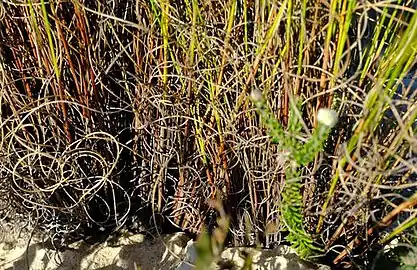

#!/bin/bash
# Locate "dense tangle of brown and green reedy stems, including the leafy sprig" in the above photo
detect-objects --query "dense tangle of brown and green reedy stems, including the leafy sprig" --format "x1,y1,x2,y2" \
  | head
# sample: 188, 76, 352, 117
0, 0, 417, 267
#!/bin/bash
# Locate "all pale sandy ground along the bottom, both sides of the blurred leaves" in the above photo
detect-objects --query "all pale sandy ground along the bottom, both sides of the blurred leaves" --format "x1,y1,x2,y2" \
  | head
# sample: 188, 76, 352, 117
0, 219, 330, 270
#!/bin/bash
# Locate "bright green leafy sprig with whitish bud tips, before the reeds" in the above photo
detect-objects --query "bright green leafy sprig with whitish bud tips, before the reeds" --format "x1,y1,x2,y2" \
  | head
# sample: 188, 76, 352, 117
251, 90, 337, 258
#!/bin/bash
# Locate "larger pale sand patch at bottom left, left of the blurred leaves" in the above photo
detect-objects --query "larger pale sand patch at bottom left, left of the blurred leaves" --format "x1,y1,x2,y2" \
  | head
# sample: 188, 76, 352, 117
0, 219, 189, 270
